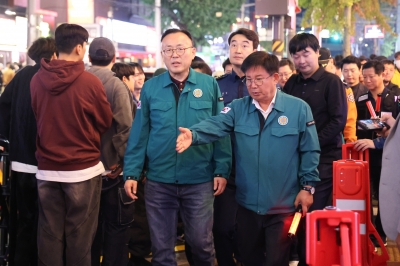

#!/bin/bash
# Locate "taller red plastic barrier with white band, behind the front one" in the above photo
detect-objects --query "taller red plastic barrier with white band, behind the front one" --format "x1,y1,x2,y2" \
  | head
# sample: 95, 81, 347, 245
333, 144, 389, 266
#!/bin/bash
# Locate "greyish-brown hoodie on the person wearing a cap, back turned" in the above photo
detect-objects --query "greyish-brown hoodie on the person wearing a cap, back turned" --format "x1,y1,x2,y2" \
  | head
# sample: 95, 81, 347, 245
88, 66, 134, 170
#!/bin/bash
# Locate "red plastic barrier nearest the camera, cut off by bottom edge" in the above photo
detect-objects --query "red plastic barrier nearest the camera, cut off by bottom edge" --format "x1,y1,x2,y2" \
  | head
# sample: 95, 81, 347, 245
306, 207, 363, 266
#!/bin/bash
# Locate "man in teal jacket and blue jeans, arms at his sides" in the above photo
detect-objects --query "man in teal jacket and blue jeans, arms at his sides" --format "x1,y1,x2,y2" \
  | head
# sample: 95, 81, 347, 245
124, 29, 232, 266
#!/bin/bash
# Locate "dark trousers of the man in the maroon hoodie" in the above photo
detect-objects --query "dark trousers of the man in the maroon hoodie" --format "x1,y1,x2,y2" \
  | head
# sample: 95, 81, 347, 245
37, 176, 101, 266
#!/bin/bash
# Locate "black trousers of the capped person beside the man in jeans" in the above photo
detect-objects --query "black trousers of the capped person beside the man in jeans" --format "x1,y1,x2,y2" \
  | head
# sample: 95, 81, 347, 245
91, 176, 134, 266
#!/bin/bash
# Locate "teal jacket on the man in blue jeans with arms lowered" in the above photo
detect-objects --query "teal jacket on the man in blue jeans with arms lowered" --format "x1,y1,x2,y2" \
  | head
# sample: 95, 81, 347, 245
124, 69, 232, 184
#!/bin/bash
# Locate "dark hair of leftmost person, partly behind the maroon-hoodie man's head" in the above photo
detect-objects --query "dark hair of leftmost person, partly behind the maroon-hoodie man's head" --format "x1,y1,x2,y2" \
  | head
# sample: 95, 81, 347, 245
28, 37, 57, 64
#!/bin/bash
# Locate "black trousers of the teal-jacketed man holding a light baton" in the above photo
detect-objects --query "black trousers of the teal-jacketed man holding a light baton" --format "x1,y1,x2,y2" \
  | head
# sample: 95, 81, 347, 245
237, 205, 294, 266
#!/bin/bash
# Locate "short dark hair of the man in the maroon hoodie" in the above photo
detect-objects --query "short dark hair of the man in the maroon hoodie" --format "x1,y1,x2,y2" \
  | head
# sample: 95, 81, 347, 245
55, 23, 89, 54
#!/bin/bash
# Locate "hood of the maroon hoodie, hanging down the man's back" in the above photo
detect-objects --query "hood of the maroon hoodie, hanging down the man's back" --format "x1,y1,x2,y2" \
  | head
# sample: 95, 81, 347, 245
36, 59, 85, 95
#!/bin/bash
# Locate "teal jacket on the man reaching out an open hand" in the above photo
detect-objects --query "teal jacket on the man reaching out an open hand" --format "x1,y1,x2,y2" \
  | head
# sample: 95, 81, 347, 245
190, 91, 320, 215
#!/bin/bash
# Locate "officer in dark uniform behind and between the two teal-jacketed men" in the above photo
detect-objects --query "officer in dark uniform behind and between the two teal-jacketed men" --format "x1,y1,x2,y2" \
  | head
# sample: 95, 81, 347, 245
213, 28, 259, 266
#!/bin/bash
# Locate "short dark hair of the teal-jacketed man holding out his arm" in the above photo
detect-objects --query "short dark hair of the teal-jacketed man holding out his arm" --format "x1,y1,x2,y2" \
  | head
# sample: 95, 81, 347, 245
240, 51, 279, 75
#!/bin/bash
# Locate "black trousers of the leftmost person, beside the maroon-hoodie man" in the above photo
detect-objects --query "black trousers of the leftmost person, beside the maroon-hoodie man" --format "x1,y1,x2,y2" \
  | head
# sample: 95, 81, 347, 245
10, 171, 39, 266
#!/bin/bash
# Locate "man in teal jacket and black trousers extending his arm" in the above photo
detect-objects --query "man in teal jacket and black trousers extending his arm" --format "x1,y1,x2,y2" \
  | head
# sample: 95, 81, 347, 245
176, 52, 320, 266
